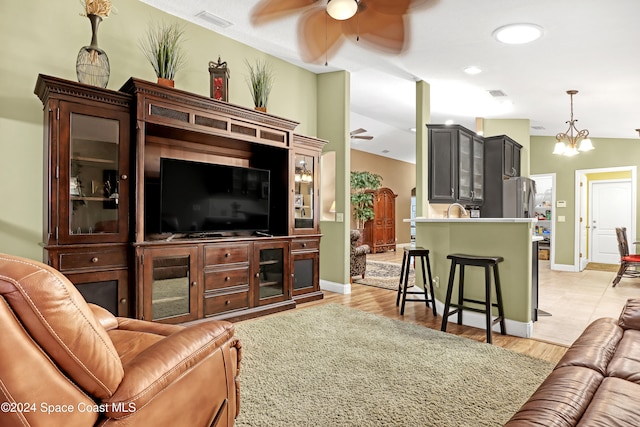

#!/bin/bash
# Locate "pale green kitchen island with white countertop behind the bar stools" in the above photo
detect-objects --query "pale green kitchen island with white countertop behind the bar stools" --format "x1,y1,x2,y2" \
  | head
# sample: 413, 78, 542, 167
405, 218, 537, 338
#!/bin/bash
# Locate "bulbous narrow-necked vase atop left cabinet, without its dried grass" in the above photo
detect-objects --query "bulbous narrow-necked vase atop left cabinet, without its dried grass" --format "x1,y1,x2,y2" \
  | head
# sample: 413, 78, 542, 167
76, 15, 110, 87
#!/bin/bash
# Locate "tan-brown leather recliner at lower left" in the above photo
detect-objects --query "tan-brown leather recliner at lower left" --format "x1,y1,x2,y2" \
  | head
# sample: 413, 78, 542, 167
0, 254, 241, 427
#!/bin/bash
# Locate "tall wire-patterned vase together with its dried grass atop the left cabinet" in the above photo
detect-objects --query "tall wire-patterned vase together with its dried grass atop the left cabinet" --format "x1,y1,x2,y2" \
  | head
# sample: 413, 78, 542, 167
76, 0, 111, 87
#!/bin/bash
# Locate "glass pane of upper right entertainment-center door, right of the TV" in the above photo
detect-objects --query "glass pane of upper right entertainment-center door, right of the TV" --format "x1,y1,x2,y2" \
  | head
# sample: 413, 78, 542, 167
293, 154, 316, 229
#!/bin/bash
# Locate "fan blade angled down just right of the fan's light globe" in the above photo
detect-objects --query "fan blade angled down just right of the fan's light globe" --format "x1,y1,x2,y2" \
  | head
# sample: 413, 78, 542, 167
345, 7, 409, 54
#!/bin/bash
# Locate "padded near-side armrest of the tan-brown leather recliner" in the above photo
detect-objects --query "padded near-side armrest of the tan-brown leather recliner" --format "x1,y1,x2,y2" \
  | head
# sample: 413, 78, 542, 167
104, 321, 238, 419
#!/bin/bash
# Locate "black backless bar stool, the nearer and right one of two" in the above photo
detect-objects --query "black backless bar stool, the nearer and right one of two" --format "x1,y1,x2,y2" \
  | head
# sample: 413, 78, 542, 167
441, 254, 506, 344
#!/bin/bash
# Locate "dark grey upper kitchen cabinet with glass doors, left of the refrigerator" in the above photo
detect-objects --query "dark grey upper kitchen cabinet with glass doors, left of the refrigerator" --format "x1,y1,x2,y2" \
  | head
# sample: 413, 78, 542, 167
427, 125, 485, 205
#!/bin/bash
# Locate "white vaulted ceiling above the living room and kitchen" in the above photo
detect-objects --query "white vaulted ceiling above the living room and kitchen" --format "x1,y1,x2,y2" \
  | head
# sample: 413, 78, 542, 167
142, 0, 640, 162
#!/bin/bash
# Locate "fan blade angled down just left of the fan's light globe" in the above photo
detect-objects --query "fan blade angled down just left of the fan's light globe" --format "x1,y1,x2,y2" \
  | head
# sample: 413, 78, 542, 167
298, 7, 345, 63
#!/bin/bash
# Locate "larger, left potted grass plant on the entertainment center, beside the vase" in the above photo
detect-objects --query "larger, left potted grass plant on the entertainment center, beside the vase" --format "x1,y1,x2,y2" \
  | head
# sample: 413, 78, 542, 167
140, 22, 185, 87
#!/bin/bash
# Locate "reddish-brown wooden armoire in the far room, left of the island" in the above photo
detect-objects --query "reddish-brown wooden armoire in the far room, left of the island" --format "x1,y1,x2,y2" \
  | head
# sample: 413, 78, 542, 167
363, 187, 398, 254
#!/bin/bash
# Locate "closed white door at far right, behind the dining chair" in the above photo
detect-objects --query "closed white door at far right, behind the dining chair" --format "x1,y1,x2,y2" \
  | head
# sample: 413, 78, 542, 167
589, 180, 632, 264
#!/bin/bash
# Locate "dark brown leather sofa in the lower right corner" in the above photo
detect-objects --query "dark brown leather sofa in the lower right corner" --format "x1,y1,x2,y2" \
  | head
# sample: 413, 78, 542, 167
506, 299, 640, 427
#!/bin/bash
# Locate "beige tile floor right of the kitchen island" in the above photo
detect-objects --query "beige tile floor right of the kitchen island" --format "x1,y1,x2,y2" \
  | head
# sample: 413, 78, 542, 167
533, 261, 640, 345
